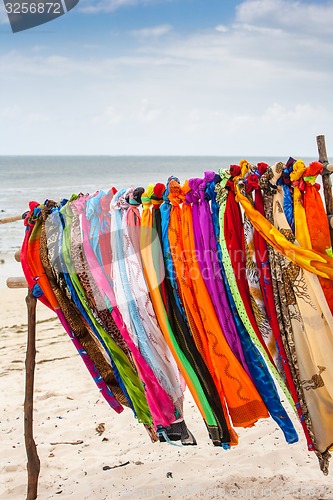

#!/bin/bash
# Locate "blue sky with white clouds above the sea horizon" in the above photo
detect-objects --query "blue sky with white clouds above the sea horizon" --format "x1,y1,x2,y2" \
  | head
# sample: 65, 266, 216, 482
0, 0, 333, 157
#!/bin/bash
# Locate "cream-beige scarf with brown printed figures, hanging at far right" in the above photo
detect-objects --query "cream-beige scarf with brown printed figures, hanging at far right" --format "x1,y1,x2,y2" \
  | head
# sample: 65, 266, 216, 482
274, 172, 333, 474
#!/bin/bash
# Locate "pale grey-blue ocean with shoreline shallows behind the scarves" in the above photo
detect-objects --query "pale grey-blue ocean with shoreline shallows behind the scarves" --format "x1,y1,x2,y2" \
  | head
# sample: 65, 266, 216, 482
0, 156, 317, 287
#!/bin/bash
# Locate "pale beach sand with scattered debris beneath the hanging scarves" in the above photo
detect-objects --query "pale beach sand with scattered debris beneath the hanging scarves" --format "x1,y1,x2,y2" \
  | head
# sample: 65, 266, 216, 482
0, 288, 333, 500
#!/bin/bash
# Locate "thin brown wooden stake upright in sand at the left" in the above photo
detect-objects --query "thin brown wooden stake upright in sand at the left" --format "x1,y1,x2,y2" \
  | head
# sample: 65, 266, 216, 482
24, 290, 40, 500
